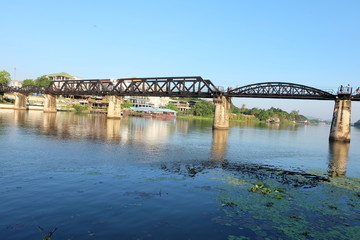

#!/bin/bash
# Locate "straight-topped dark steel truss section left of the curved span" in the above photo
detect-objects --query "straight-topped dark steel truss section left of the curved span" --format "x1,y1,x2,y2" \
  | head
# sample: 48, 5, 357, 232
47, 77, 220, 98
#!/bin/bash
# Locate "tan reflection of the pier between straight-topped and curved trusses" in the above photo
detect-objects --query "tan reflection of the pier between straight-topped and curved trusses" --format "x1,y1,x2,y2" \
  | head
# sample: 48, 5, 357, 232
211, 129, 229, 162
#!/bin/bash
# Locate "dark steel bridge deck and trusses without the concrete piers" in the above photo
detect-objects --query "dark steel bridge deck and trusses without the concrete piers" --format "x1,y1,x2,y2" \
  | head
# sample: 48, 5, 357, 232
0, 77, 360, 101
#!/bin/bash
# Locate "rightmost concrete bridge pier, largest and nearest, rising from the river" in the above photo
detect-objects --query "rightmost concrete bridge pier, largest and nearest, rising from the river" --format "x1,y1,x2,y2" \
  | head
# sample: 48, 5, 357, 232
329, 99, 351, 142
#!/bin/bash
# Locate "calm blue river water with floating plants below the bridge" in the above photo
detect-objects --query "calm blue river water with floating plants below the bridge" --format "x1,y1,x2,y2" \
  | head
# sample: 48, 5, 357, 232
0, 110, 360, 240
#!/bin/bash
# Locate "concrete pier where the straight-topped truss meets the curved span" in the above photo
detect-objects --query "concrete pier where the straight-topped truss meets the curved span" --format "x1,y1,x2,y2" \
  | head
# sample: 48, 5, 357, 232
213, 96, 231, 129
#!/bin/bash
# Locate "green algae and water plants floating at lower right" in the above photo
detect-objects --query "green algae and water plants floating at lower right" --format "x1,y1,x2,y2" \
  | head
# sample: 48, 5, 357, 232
212, 173, 360, 240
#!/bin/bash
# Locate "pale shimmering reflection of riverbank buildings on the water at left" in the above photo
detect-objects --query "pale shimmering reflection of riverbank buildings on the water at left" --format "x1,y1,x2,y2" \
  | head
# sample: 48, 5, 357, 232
0, 110, 179, 145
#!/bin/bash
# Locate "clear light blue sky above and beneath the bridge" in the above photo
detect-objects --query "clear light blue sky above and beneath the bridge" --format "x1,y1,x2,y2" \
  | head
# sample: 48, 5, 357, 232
0, 0, 360, 121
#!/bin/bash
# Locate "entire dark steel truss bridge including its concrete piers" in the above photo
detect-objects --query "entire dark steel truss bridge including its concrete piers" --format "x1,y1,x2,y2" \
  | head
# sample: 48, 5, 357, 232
0, 77, 360, 142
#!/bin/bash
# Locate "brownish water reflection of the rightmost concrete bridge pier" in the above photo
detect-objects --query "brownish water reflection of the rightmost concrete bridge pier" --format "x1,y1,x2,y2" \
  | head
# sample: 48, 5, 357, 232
328, 142, 350, 177
